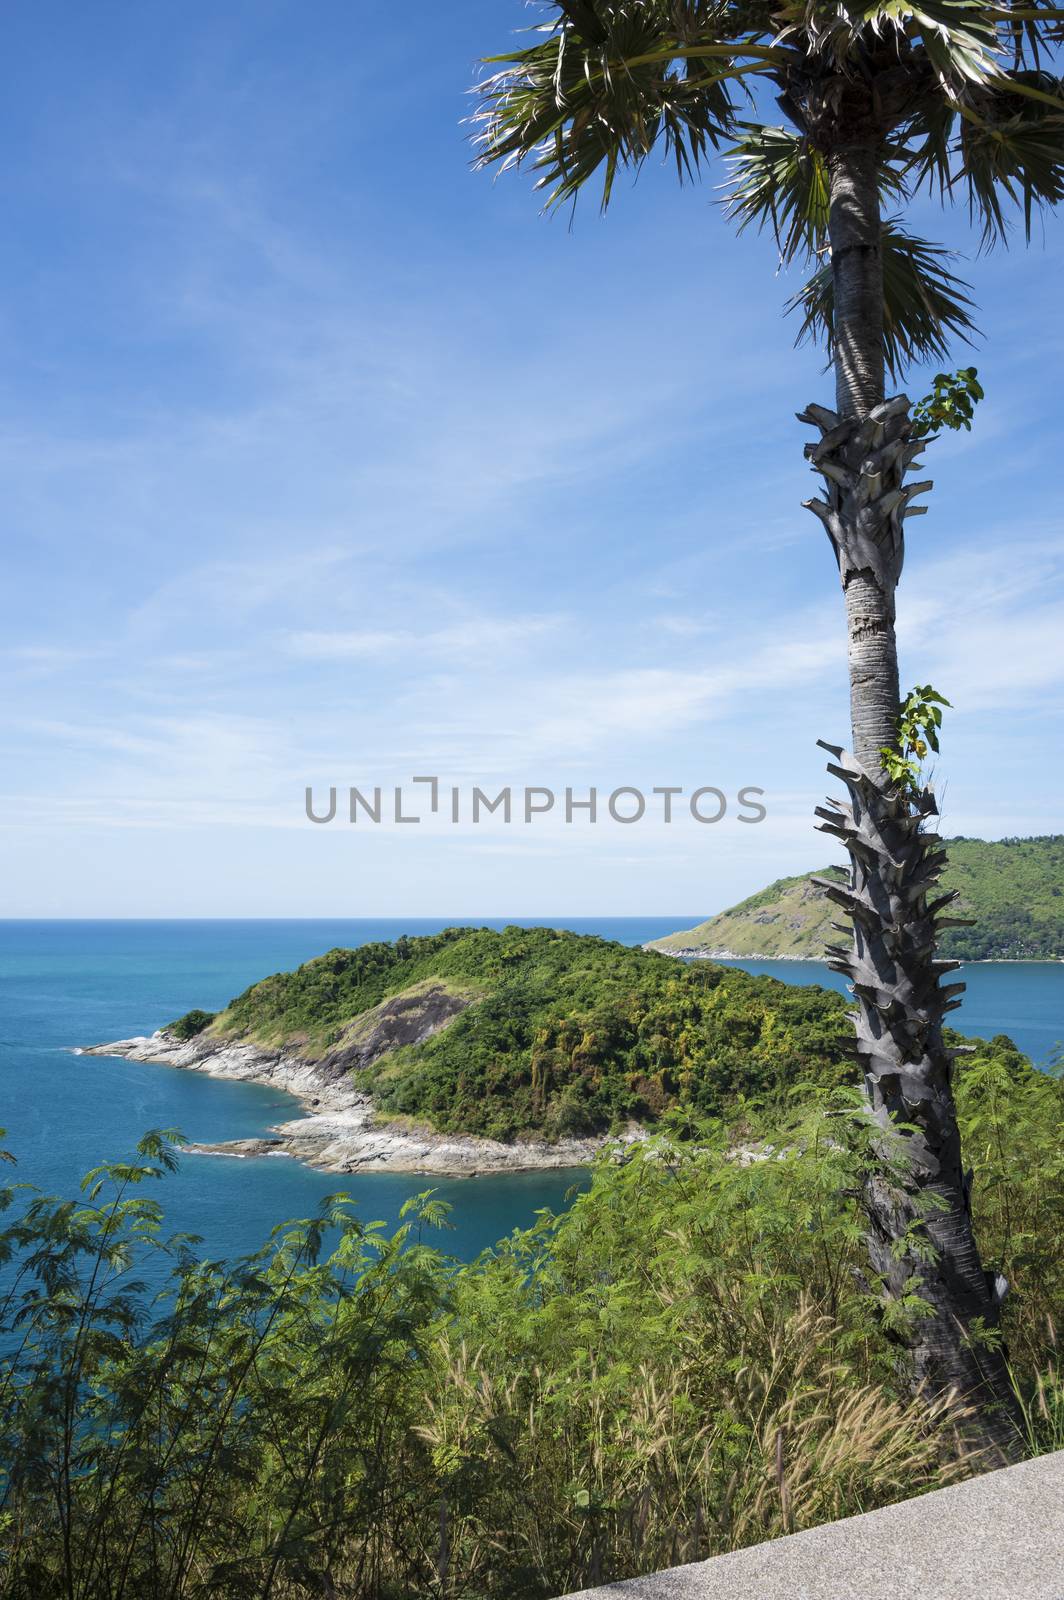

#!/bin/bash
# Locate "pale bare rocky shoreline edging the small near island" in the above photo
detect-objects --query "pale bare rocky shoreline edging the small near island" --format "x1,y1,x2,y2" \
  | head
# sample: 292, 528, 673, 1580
80, 1029, 617, 1178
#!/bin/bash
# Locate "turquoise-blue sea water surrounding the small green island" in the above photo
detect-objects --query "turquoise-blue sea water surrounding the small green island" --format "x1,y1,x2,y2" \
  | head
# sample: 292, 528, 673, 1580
0, 915, 1064, 1258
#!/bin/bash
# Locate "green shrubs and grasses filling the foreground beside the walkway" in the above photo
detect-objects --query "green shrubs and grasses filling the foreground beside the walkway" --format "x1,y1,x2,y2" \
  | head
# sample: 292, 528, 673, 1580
0, 1046, 1064, 1600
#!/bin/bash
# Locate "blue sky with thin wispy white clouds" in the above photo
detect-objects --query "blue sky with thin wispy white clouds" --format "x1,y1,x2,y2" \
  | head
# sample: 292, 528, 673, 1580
0, 0, 1064, 917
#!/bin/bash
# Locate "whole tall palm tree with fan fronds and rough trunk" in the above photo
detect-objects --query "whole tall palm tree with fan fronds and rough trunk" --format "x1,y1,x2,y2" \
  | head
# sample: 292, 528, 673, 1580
477, 0, 1064, 1458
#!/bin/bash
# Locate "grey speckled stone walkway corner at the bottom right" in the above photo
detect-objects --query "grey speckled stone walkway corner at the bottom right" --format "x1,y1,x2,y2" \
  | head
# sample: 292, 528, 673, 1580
569, 1451, 1064, 1600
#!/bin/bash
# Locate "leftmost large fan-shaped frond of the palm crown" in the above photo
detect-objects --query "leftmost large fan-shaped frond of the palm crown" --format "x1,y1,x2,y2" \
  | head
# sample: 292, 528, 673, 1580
474, 0, 782, 208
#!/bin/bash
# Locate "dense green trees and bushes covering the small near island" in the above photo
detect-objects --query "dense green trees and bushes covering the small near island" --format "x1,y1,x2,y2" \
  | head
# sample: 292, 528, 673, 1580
172, 928, 851, 1139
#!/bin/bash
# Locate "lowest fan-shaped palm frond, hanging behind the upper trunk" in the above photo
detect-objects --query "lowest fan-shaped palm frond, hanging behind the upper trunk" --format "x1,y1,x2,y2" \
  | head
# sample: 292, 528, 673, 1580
787, 222, 976, 379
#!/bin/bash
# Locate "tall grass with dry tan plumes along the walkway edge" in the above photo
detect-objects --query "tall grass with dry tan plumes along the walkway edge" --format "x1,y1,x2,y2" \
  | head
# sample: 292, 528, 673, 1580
418, 1298, 963, 1595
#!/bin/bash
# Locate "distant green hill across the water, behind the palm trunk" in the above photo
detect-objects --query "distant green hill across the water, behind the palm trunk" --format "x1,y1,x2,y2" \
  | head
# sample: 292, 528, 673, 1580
651, 834, 1064, 962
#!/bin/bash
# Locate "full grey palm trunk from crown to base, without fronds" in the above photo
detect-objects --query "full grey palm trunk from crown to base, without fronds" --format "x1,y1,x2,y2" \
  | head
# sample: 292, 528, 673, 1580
802, 147, 1021, 1462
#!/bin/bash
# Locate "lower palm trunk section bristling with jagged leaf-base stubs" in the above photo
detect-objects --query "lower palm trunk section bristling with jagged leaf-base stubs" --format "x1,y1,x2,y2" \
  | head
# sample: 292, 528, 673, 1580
813, 746, 1019, 1461
